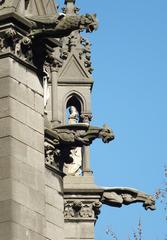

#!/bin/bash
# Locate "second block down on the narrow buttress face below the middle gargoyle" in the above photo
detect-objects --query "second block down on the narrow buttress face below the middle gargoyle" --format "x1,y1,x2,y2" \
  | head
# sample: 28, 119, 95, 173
45, 186, 64, 212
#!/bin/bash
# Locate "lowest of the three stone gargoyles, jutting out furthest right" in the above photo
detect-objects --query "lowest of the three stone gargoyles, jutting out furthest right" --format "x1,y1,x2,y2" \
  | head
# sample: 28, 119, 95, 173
102, 188, 155, 210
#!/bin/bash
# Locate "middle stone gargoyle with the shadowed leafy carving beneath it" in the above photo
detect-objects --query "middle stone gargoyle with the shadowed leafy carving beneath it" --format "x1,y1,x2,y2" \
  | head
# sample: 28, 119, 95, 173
45, 124, 114, 165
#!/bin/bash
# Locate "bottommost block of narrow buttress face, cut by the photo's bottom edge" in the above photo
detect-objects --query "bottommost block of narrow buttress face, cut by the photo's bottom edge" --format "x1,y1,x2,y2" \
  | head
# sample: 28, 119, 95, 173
46, 222, 64, 240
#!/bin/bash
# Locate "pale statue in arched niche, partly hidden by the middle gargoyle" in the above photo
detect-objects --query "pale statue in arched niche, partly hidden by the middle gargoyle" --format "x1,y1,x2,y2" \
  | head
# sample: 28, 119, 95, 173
64, 106, 82, 176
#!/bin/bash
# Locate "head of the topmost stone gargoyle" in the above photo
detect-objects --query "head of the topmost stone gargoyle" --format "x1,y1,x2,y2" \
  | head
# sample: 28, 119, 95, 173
81, 14, 98, 32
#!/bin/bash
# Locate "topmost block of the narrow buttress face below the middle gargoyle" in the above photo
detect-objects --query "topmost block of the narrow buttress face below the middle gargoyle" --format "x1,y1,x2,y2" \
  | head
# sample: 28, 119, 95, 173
45, 169, 63, 192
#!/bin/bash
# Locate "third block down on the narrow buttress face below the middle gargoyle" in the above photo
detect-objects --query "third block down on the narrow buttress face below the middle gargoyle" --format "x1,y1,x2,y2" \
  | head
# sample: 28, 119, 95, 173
46, 204, 64, 228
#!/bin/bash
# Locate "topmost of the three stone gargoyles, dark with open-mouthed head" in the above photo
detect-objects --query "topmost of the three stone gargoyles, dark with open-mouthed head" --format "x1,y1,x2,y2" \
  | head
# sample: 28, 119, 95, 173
27, 14, 98, 38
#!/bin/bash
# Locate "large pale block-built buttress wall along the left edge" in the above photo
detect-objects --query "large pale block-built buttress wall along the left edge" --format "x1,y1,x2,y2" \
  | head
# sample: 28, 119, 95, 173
0, 57, 46, 240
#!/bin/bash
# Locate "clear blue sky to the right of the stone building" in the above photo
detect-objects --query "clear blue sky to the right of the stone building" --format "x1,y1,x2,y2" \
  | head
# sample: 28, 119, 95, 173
57, 0, 167, 240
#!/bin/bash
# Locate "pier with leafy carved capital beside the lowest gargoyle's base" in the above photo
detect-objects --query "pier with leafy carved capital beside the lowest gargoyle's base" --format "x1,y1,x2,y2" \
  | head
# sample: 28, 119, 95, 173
64, 189, 102, 240
